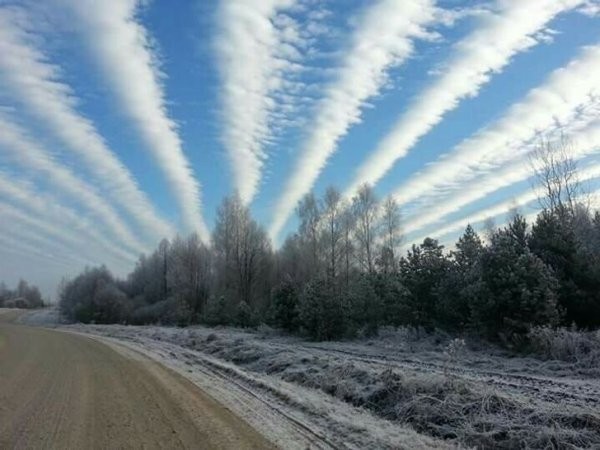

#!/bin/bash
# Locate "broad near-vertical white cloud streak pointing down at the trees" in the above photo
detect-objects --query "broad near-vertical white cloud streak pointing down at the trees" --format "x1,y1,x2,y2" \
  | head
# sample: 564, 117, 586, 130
215, 0, 300, 203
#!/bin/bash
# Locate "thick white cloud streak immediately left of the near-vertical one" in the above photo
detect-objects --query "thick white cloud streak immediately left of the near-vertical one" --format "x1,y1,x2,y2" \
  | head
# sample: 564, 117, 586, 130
56, 0, 209, 242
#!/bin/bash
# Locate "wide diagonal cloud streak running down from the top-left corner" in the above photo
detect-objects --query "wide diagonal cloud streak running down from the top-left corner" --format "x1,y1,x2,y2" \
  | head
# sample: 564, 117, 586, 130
0, 7, 173, 241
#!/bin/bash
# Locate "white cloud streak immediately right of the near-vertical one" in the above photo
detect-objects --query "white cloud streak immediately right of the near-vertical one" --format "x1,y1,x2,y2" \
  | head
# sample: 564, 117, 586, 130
270, 0, 435, 240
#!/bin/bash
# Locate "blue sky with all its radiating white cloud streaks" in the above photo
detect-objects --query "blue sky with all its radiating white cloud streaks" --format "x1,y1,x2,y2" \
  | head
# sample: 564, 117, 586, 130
0, 0, 600, 297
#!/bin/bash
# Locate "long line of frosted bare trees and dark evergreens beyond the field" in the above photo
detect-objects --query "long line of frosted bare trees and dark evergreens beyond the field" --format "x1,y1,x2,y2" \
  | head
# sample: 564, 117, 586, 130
60, 186, 600, 344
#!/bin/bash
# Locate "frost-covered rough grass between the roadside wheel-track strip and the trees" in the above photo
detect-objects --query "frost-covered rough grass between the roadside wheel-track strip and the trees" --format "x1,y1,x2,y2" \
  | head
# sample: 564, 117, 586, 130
48, 326, 600, 448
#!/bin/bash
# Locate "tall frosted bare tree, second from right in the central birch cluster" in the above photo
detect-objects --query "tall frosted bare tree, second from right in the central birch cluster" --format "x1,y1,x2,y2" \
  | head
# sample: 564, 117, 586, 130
352, 184, 379, 272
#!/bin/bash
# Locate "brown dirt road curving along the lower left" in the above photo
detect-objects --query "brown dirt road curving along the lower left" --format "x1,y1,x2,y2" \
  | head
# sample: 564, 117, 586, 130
0, 313, 272, 449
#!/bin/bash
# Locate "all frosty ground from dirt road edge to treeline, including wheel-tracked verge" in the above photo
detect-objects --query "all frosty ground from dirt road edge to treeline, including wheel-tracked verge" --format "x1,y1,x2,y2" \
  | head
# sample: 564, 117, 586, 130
24, 310, 600, 449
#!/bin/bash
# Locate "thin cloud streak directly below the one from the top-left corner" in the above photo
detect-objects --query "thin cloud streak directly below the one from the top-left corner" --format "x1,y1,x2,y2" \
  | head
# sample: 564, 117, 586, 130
0, 114, 147, 253
